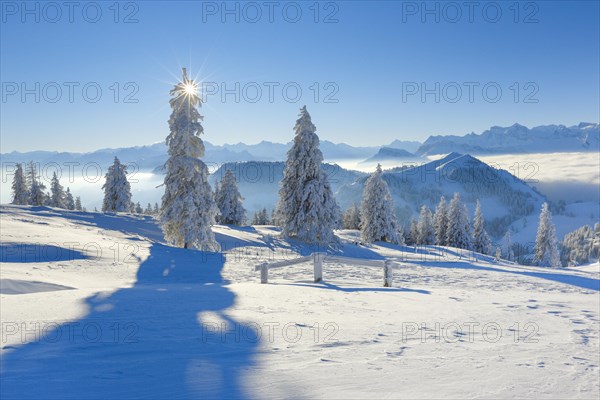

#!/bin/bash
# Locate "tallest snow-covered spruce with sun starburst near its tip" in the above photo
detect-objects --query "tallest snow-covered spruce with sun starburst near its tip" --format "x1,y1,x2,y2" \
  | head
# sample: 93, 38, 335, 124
160, 68, 220, 251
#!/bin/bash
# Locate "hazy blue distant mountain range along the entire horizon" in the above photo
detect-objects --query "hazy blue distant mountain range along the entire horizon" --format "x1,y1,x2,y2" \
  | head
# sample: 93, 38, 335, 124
1, 122, 600, 170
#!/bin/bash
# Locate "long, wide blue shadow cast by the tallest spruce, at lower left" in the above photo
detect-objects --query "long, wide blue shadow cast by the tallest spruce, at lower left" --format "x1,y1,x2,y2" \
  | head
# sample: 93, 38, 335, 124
0, 244, 257, 399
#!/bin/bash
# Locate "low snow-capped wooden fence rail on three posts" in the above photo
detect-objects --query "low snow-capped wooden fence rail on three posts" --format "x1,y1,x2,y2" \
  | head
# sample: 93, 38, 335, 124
254, 253, 398, 287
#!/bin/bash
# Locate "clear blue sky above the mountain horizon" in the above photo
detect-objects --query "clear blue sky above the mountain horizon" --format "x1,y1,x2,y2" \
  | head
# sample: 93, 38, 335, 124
0, 1, 600, 152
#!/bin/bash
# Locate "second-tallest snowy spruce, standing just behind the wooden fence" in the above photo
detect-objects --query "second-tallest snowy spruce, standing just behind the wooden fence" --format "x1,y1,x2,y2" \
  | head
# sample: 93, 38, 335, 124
276, 106, 341, 244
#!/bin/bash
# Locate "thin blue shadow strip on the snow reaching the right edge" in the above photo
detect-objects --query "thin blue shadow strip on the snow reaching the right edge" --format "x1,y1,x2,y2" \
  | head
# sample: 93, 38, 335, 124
406, 261, 600, 292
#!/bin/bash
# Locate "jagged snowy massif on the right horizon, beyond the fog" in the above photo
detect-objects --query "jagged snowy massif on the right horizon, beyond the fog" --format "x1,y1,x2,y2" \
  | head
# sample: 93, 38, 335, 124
416, 122, 600, 156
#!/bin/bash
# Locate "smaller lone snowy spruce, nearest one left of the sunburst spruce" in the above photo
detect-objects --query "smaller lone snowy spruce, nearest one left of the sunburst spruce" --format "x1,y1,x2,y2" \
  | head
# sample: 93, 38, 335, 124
102, 157, 131, 212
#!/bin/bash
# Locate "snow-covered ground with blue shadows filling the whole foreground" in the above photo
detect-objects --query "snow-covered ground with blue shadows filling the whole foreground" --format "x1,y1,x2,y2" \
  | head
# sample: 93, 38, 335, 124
0, 206, 600, 399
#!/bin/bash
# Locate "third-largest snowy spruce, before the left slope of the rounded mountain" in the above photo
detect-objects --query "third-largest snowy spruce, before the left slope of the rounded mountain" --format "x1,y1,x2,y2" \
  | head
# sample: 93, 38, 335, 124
360, 164, 402, 244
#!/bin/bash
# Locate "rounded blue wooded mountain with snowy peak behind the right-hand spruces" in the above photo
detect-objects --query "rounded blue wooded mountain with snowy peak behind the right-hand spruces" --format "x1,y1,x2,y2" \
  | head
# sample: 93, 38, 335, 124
337, 153, 544, 236
